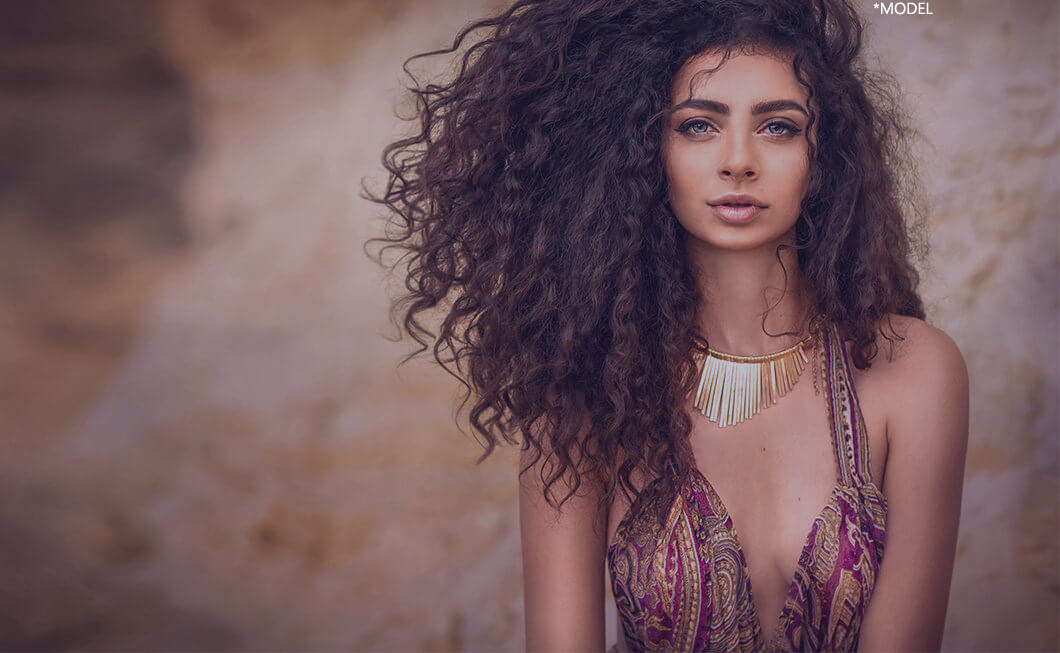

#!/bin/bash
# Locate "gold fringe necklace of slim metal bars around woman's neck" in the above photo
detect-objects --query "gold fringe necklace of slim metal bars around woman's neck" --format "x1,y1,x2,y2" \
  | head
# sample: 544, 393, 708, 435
692, 330, 817, 426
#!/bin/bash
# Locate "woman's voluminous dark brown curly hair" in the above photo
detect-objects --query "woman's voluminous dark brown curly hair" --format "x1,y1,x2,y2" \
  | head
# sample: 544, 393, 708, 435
363, 0, 925, 515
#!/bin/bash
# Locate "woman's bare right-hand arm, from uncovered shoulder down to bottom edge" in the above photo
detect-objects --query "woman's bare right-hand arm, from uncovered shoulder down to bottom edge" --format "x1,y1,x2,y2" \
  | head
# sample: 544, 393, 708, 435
859, 320, 969, 651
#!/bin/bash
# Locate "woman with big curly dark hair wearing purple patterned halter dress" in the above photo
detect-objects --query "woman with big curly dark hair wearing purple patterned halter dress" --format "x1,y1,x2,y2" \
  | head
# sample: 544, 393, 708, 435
369, 0, 968, 651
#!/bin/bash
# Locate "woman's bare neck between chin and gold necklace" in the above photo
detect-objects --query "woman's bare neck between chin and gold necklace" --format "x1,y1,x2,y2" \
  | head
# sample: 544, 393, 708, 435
688, 230, 813, 356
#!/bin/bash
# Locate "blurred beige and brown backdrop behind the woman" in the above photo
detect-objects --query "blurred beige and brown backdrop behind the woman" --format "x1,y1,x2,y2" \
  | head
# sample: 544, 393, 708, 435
0, 0, 1060, 651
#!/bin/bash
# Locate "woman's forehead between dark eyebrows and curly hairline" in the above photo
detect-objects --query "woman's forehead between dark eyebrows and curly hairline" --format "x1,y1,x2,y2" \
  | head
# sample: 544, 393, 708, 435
671, 52, 807, 104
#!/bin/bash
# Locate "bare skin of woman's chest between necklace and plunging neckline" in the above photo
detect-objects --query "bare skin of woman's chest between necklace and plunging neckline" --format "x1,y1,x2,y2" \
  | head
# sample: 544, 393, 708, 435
607, 347, 887, 648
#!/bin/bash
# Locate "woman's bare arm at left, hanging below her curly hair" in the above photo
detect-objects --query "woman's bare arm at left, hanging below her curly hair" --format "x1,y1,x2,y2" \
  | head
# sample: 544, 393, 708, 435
519, 421, 606, 651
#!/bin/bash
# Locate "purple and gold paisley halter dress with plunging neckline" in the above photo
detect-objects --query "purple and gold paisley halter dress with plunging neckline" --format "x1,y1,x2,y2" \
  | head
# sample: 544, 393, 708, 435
607, 324, 887, 651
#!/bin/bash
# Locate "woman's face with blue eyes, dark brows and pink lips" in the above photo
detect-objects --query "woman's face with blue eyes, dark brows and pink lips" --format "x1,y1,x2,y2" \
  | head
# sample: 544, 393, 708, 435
661, 48, 810, 249
